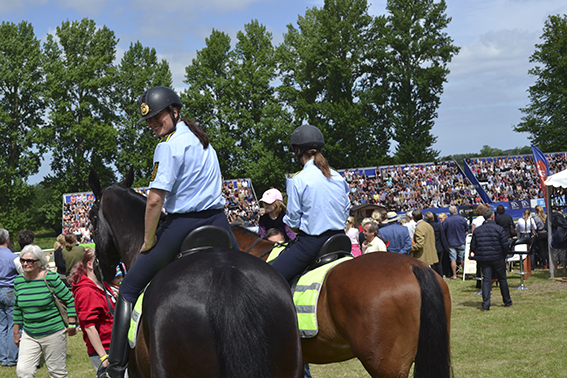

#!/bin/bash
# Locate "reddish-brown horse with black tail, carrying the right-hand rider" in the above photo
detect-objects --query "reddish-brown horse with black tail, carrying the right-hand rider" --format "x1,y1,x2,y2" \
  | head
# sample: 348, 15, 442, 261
232, 226, 452, 378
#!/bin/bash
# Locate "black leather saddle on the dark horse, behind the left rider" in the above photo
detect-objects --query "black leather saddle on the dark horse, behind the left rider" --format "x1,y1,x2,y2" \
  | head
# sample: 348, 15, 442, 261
177, 225, 232, 258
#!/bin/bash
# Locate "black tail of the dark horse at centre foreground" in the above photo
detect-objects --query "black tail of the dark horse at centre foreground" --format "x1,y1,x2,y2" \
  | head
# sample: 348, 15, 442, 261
207, 267, 278, 378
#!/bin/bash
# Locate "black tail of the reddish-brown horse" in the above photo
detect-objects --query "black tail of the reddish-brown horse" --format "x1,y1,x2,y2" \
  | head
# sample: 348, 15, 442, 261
412, 265, 453, 378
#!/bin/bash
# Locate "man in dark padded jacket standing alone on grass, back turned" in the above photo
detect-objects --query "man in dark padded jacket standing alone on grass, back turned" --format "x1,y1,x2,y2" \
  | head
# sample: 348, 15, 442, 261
470, 207, 512, 311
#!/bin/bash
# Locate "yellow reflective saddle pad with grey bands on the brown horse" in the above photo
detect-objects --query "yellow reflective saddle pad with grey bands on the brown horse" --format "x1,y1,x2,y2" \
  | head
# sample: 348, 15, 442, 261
293, 257, 353, 339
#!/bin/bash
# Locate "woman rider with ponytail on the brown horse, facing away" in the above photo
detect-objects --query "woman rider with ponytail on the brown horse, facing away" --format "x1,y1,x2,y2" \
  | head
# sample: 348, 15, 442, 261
272, 125, 350, 281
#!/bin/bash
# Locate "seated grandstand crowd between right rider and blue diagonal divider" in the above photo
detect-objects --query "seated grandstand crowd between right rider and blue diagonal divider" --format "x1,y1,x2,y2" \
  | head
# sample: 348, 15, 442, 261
342, 162, 481, 212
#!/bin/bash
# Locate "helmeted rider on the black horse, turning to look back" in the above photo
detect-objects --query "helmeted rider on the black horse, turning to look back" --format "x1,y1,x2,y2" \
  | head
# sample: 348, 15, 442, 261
105, 87, 238, 378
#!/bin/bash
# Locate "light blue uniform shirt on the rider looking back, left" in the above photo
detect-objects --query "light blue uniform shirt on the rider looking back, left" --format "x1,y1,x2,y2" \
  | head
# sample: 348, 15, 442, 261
150, 122, 225, 213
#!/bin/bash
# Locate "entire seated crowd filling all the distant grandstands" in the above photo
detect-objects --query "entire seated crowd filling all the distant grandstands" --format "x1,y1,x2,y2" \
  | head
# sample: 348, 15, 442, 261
63, 153, 567, 233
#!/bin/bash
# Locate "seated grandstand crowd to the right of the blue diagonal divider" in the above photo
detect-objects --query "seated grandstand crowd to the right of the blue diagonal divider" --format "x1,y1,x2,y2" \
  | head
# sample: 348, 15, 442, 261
467, 153, 567, 202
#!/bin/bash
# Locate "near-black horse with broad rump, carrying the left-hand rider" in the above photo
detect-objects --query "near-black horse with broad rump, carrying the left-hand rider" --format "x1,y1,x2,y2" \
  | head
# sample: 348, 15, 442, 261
89, 170, 303, 378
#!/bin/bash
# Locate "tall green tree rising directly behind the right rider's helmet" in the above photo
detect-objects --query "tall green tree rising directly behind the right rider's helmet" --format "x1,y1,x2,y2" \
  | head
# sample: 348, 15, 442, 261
278, 0, 389, 168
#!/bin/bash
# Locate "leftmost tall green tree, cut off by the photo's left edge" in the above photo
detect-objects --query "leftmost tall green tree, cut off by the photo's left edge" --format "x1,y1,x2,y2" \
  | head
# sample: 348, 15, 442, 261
0, 21, 45, 232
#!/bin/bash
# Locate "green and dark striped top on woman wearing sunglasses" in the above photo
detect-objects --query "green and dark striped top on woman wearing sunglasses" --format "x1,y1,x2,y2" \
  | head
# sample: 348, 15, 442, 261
14, 271, 77, 337
